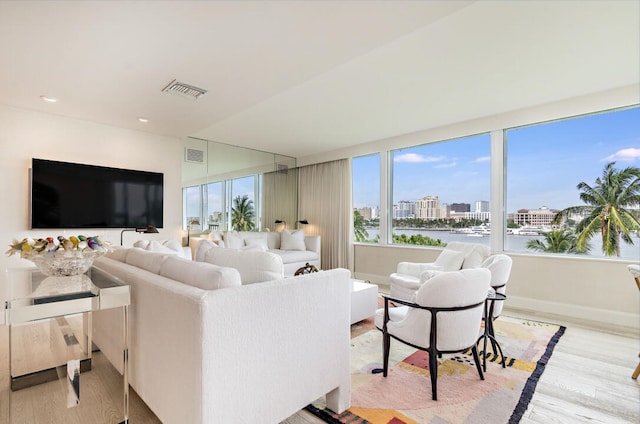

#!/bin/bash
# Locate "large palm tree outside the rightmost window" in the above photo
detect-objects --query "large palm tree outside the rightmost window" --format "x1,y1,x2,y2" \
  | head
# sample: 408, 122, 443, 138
554, 162, 640, 256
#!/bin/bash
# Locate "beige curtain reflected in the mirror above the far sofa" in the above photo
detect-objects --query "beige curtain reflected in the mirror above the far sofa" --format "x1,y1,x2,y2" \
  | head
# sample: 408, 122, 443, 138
261, 168, 298, 231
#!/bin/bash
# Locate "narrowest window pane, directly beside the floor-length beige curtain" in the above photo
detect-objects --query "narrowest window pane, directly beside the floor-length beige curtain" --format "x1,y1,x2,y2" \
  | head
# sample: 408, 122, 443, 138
351, 154, 380, 243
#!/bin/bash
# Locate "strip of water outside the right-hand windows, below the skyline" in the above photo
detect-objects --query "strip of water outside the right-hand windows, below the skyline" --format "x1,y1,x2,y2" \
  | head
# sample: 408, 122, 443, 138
367, 228, 640, 261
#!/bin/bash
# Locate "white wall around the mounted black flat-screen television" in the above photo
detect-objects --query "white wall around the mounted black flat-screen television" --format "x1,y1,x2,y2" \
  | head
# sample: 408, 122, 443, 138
0, 105, 183, 276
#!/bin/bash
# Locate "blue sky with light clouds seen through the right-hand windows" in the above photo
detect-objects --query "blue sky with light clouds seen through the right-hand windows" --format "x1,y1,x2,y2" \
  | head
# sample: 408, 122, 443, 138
353, 107, 640, 212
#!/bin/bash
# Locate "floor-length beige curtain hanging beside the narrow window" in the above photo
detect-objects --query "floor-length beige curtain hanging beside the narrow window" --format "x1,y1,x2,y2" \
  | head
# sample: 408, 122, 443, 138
298, 159, 353, 270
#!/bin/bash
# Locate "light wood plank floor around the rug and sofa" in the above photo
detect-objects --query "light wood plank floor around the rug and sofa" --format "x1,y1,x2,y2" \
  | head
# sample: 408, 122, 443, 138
0, 311, 640, 424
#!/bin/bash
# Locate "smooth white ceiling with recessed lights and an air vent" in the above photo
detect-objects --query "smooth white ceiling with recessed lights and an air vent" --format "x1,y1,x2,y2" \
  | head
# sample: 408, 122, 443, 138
0, 1, 640, 157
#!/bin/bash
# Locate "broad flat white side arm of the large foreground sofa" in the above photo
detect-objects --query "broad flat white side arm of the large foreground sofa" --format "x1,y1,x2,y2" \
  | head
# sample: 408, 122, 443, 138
202, 269, 351, 423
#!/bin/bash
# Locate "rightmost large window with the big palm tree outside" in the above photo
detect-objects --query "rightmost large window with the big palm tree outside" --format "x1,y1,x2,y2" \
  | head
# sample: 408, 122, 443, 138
505, 107, 640, 259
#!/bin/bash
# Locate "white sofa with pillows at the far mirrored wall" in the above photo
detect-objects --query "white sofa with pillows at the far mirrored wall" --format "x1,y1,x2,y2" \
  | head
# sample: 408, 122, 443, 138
190, 230, 322, 275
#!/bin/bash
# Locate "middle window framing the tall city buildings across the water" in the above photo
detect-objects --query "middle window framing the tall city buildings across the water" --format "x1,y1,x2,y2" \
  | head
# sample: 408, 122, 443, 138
390, 134, 491, 246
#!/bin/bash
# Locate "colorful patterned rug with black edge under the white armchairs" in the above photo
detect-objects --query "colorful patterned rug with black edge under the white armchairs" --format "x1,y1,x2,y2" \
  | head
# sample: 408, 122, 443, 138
306, 316, 565, 424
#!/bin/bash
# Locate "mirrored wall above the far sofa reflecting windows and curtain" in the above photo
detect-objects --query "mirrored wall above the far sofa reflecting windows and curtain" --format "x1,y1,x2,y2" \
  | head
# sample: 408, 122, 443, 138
182, 137, 298, 236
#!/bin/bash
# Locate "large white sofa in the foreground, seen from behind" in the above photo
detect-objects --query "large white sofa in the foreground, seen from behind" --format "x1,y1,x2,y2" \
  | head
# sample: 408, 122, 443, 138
92, 248, 351, 424
